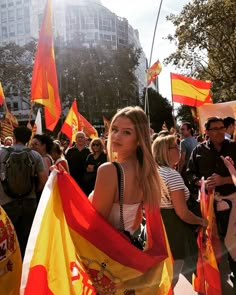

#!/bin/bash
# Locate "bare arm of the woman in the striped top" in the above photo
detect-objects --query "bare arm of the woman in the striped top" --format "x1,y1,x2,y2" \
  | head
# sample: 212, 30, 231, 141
170, 190, 208, 227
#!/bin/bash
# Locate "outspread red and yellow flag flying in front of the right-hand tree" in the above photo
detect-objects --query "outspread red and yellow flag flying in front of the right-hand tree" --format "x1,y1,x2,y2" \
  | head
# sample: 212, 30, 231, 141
171, 73, 212, 107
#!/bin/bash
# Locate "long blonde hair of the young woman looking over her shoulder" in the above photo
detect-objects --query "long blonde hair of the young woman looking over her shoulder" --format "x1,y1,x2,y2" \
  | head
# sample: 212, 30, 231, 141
108, 106, 162, 208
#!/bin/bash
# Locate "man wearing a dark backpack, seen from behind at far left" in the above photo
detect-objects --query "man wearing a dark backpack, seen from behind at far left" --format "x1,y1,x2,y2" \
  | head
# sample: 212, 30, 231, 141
0, 126, 47, 257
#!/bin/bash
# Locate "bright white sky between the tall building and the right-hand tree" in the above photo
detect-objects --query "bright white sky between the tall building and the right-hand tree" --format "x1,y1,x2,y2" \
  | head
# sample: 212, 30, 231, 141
101, 0, 190, 101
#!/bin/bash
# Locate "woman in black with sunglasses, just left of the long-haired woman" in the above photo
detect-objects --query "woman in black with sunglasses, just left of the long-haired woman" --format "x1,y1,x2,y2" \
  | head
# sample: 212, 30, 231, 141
84, 138, 107, 196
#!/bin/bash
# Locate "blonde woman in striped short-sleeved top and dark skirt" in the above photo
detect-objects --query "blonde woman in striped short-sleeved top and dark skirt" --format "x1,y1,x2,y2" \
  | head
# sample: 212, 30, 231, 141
152, 135, 207, 286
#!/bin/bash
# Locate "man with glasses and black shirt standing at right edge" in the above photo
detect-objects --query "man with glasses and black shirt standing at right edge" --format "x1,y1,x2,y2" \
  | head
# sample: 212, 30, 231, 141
186, 117, 236, 288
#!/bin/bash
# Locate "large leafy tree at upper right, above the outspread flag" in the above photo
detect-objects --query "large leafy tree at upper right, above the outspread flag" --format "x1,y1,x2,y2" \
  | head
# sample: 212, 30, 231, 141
165, 0, 236, 102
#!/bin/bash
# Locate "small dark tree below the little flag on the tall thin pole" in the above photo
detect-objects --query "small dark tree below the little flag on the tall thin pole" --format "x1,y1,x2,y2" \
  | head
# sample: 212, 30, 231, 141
143, 88, 174, 132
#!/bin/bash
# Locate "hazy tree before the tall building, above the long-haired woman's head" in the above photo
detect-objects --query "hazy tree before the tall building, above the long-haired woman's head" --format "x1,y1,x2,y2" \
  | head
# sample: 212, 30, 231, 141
55, 47, 140, 124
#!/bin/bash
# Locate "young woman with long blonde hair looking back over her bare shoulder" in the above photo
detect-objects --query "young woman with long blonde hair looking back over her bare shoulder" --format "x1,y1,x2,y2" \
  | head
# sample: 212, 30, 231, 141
90, 107, 164, 243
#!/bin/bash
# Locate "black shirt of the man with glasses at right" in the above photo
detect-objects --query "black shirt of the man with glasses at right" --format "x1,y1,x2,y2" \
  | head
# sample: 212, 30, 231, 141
186, 140, 236, 196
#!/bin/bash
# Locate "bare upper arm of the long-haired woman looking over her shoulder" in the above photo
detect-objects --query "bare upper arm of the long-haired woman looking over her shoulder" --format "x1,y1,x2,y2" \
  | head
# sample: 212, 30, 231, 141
90, 163, 118, 219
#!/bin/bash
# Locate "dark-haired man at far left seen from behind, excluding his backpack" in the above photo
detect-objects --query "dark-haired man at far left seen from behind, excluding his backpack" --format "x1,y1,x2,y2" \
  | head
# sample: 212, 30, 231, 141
0, 126, 47, 258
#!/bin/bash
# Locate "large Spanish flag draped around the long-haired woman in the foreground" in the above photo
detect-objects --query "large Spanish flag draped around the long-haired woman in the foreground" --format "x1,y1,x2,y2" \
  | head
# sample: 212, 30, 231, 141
21, 171, 172, 295
